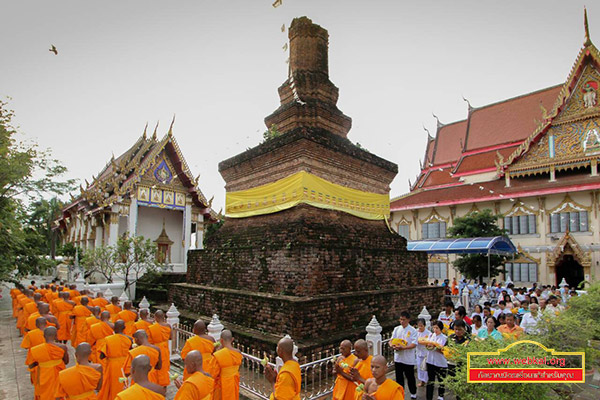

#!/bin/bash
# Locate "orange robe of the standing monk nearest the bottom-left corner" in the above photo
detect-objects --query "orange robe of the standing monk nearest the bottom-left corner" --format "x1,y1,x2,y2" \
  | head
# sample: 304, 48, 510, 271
25, 343, 65, 400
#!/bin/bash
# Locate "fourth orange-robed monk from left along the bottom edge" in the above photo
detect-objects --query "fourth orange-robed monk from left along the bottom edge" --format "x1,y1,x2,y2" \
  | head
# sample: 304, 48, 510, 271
174, 350, 214, 400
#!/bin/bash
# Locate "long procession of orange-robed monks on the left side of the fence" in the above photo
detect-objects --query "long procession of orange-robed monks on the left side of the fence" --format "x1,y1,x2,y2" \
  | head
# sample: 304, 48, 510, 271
10, 280, 308, 400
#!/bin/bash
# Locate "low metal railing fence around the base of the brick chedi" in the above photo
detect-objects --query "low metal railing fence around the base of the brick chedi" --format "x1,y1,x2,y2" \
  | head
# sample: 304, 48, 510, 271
172, 324, 394, 400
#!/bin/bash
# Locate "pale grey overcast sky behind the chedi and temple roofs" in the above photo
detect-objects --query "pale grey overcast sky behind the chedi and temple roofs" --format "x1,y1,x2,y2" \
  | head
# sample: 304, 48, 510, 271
0, 0, 600, 211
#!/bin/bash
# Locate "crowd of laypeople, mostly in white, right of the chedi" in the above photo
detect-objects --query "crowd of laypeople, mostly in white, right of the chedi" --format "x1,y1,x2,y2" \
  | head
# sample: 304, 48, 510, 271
390, 281, 578, 400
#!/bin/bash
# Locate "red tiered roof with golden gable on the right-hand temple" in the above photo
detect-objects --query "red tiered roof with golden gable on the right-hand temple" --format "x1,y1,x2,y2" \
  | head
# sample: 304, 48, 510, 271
391, 12, 600, 211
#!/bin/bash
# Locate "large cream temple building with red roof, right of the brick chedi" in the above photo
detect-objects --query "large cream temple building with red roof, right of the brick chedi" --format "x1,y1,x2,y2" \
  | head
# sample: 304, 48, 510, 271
391, 15, 600, 285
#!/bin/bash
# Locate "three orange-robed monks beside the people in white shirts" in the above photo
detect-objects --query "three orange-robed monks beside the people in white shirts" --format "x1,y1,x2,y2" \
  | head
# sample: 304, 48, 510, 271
333, 339, 404, 400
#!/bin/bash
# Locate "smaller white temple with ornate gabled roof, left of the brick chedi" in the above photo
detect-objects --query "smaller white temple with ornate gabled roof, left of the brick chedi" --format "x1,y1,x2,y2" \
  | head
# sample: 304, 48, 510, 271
55, 124, 215, 271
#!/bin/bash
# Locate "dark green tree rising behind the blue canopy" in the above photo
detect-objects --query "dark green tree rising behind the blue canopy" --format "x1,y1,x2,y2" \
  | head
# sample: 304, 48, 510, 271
448, 209, 506, 282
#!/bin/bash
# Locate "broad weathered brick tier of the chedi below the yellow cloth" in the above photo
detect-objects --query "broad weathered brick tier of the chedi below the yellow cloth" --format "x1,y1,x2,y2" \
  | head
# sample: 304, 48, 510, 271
187, 205, 427, 296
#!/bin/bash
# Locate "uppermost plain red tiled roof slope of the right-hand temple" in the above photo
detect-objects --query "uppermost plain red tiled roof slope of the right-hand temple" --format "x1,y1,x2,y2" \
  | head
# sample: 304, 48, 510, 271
466, 84, 562, 151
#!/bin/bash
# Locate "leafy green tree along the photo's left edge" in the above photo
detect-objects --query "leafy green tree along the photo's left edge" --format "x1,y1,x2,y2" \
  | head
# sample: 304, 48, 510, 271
0, 100, 74, 280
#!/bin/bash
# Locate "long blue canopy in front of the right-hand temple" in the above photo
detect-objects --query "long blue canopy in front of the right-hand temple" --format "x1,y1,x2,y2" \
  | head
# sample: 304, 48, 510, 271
407, 236, 517, 254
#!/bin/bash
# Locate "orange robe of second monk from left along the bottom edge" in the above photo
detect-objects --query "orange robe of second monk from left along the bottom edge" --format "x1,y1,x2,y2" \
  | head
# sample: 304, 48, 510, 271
55, 364, 102, 400
